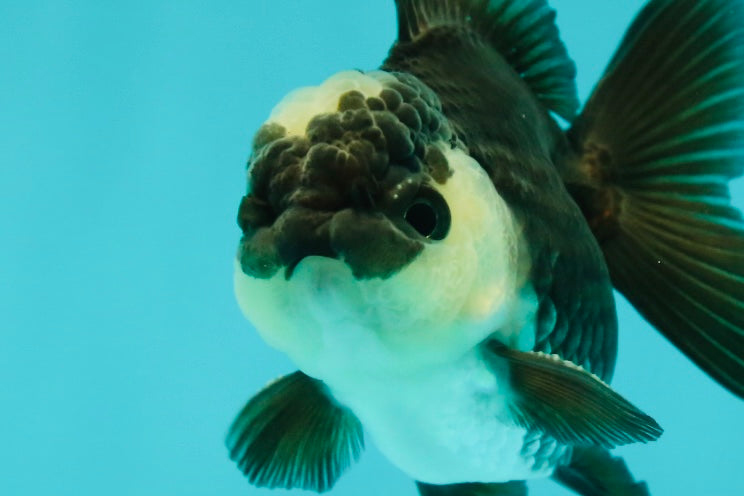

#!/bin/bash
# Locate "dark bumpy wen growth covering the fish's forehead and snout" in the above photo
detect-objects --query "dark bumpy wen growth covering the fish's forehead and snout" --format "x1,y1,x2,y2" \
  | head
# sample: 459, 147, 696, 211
238, 74, 462, 279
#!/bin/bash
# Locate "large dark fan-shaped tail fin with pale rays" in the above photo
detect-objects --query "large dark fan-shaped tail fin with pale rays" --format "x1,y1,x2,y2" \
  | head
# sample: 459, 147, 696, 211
567, 0, 744, 398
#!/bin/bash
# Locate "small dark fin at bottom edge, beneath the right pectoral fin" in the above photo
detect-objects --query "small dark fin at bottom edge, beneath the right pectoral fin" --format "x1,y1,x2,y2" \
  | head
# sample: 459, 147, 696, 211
553, 446, 650, 496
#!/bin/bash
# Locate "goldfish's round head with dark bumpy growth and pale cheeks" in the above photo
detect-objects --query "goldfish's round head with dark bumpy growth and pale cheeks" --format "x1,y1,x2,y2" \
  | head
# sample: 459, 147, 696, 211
235, 72, 525, 377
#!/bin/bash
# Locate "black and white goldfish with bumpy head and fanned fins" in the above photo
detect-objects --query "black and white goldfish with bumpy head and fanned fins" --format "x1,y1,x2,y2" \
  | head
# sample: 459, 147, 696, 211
226, 0, 744, 496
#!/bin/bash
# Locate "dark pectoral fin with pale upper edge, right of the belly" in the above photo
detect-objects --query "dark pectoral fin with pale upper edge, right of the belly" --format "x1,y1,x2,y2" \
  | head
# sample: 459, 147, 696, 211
488, 342, 663, 448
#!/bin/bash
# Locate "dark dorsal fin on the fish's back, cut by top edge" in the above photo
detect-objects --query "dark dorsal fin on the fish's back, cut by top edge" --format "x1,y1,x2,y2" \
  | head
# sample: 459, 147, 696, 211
395, 0, 579, 120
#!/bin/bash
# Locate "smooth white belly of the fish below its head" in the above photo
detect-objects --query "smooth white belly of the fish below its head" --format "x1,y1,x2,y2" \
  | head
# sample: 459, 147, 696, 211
329, 350, 553, 484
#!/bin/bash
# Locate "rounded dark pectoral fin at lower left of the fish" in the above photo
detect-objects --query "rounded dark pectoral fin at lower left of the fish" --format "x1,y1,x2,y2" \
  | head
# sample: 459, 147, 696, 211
226, 372, 364, 492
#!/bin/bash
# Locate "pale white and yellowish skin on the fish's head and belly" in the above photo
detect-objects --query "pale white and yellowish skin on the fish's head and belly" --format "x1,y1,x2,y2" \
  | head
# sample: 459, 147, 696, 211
235, 72, 551, 483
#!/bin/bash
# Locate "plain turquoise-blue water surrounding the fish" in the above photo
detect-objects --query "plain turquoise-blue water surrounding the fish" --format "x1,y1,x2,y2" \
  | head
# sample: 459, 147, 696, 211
0, 0, 744, 496
